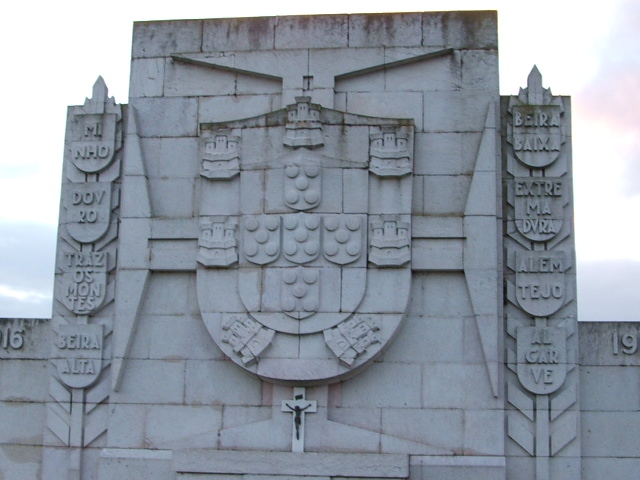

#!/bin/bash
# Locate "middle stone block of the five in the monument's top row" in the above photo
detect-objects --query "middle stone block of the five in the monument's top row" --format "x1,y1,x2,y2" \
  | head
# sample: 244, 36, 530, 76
275, 15, 349, 49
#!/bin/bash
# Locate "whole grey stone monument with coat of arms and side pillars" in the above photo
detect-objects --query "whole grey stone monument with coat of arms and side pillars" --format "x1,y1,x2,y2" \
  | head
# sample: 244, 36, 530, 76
0, 12, 640, 480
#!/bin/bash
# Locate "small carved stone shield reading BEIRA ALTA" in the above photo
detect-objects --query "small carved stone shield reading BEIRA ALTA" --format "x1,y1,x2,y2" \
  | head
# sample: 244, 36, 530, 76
53, 325, 103, 388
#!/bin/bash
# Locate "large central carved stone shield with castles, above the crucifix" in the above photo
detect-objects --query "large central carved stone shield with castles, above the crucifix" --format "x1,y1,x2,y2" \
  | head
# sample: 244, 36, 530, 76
197, 97, 413, 385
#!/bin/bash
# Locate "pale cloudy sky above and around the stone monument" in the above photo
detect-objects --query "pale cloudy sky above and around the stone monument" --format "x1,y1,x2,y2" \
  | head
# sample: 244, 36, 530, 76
0, 0, 640, 321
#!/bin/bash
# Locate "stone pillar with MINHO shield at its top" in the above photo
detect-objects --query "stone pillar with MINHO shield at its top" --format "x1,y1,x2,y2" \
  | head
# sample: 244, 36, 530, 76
42, 77, 123, 480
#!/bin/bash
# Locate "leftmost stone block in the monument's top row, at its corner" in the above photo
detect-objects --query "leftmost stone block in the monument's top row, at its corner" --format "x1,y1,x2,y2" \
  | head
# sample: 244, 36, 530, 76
132, 20, 202, 58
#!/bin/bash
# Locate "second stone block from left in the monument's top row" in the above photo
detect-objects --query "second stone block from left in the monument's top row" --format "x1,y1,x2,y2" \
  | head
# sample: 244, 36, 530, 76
202, 17, 279, 52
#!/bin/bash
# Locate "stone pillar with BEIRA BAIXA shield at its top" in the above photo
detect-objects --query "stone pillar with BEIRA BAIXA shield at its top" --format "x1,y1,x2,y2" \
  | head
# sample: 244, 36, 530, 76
502, 67, 581, 480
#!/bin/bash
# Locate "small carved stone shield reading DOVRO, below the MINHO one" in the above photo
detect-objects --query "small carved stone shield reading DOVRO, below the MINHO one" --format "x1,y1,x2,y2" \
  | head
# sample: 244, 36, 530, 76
63, 182, 111, 243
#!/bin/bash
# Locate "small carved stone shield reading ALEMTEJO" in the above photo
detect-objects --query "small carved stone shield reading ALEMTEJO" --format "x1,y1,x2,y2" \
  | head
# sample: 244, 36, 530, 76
515, 251, 567, 317
